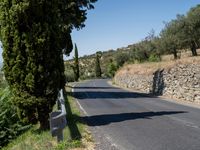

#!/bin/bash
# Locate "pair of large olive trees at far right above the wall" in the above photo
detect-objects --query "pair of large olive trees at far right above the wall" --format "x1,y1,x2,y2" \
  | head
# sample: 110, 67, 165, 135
161, 5, 200, 59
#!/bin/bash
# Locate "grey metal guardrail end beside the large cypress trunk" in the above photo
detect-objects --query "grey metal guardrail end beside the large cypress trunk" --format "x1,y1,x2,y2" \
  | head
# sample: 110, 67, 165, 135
50, 89, 67, 142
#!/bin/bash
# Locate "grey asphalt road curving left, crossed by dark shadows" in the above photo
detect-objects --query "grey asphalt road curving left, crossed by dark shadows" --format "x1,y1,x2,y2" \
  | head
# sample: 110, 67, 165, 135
74, 79, 200, 150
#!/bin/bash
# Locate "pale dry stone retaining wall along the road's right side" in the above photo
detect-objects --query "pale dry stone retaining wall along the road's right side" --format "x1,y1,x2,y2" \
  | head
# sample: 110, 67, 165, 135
114, 64, 200, 104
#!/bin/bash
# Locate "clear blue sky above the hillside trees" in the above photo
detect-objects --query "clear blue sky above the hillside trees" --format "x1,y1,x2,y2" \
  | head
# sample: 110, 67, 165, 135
0, 0, 200, 62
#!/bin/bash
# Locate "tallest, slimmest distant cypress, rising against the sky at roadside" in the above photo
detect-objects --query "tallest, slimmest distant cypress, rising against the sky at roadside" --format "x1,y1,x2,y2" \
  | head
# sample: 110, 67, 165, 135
74, 44, 79, 81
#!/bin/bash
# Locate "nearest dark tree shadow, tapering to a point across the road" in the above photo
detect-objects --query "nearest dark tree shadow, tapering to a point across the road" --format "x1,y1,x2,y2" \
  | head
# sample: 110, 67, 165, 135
82, 111, 187, 126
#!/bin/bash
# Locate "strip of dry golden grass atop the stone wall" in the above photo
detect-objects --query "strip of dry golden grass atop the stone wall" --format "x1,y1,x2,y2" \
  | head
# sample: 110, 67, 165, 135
117, 54, 200, 75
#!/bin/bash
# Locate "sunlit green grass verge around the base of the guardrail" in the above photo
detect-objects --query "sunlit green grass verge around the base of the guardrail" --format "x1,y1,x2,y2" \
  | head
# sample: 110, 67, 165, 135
2, 88, 93, 150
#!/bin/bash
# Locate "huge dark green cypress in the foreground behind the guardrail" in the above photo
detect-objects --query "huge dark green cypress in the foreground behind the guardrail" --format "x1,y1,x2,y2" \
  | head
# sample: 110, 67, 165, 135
0, 0, 96, 129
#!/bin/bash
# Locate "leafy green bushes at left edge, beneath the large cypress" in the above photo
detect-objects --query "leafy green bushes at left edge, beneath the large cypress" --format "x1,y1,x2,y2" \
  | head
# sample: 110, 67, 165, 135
0, 88, 30, 149
